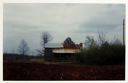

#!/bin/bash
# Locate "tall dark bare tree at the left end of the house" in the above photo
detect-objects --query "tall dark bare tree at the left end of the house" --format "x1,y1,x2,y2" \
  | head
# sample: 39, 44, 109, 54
41, 32, 53, 53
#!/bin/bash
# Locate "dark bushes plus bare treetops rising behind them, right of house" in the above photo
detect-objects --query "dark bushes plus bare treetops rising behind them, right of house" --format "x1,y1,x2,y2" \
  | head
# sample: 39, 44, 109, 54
75, 33, 125, 65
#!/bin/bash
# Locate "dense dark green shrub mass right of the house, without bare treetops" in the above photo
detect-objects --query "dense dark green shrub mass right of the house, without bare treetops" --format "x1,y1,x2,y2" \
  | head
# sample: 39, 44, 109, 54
76, 43, 125, 65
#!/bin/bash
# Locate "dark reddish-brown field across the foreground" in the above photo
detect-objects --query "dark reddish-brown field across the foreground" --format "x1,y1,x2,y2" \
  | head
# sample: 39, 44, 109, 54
3, 62, 125, 80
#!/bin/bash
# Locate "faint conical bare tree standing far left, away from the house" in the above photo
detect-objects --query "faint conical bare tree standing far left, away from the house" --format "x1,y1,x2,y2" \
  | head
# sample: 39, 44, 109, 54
18, 40, 29, 55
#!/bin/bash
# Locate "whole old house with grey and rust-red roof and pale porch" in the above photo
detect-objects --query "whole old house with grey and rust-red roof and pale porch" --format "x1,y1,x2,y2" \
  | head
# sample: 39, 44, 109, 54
45, 43, 82, 60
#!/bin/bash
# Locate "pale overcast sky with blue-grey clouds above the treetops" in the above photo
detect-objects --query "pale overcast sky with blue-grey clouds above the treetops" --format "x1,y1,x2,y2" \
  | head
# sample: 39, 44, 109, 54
3, 3, 125, 52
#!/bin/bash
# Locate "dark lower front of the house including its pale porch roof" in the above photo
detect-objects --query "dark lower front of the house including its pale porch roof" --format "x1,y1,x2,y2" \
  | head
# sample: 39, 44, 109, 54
45, 48, 80, 61
